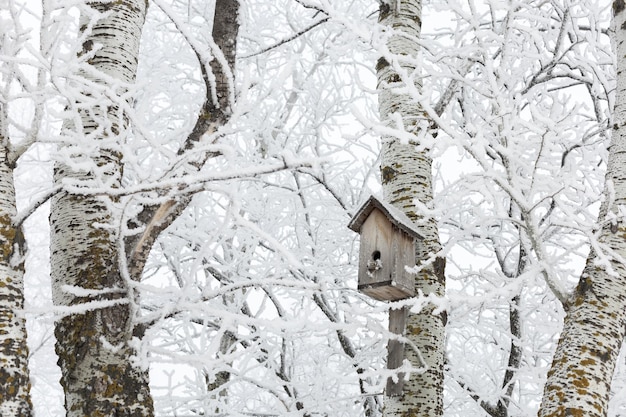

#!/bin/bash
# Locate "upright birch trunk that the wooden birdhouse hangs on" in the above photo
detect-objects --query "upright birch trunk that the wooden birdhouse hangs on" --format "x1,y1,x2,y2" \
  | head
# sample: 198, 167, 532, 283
376, 0, 445, 417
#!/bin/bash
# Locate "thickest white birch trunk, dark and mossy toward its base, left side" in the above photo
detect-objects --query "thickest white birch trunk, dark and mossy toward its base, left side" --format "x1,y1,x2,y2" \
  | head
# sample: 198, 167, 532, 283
50, 0, 154, 417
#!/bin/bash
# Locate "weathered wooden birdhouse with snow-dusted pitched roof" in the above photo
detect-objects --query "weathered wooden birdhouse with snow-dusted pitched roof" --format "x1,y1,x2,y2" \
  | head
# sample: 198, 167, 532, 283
348, 196, 422, 301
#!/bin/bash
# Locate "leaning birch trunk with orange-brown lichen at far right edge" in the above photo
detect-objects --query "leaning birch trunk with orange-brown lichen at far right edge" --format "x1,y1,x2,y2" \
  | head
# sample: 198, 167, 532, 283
539, 0, 626, 417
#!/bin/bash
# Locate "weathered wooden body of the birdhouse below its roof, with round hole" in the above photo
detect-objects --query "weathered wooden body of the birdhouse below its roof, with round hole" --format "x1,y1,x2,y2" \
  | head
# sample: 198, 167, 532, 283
358, 209, 415, 301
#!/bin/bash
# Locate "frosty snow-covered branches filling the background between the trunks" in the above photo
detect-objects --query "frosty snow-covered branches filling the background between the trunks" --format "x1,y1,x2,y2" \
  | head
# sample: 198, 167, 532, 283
0, 0, 626, 417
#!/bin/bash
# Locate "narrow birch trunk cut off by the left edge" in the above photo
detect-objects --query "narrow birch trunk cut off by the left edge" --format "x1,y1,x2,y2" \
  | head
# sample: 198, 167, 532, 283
0, 104, 32, 417
